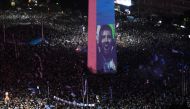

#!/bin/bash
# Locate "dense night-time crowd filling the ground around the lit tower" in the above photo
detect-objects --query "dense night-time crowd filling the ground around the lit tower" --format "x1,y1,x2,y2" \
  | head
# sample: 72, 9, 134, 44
0, 9, 190, 109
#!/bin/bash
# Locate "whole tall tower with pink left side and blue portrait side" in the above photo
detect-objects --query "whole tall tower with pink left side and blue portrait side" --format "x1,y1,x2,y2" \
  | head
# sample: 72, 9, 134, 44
88, 0, 117, 73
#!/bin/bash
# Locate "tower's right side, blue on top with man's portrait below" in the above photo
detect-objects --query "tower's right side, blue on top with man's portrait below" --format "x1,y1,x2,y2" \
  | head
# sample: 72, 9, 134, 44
96, 0, 117, 73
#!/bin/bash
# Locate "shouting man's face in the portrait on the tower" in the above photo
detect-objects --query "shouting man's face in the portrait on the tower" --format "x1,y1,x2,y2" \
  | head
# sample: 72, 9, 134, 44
100, 29, 112, 55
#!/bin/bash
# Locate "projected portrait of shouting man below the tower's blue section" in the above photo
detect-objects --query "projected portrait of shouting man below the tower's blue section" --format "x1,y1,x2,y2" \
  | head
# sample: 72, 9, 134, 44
97, 24, 116, 73
